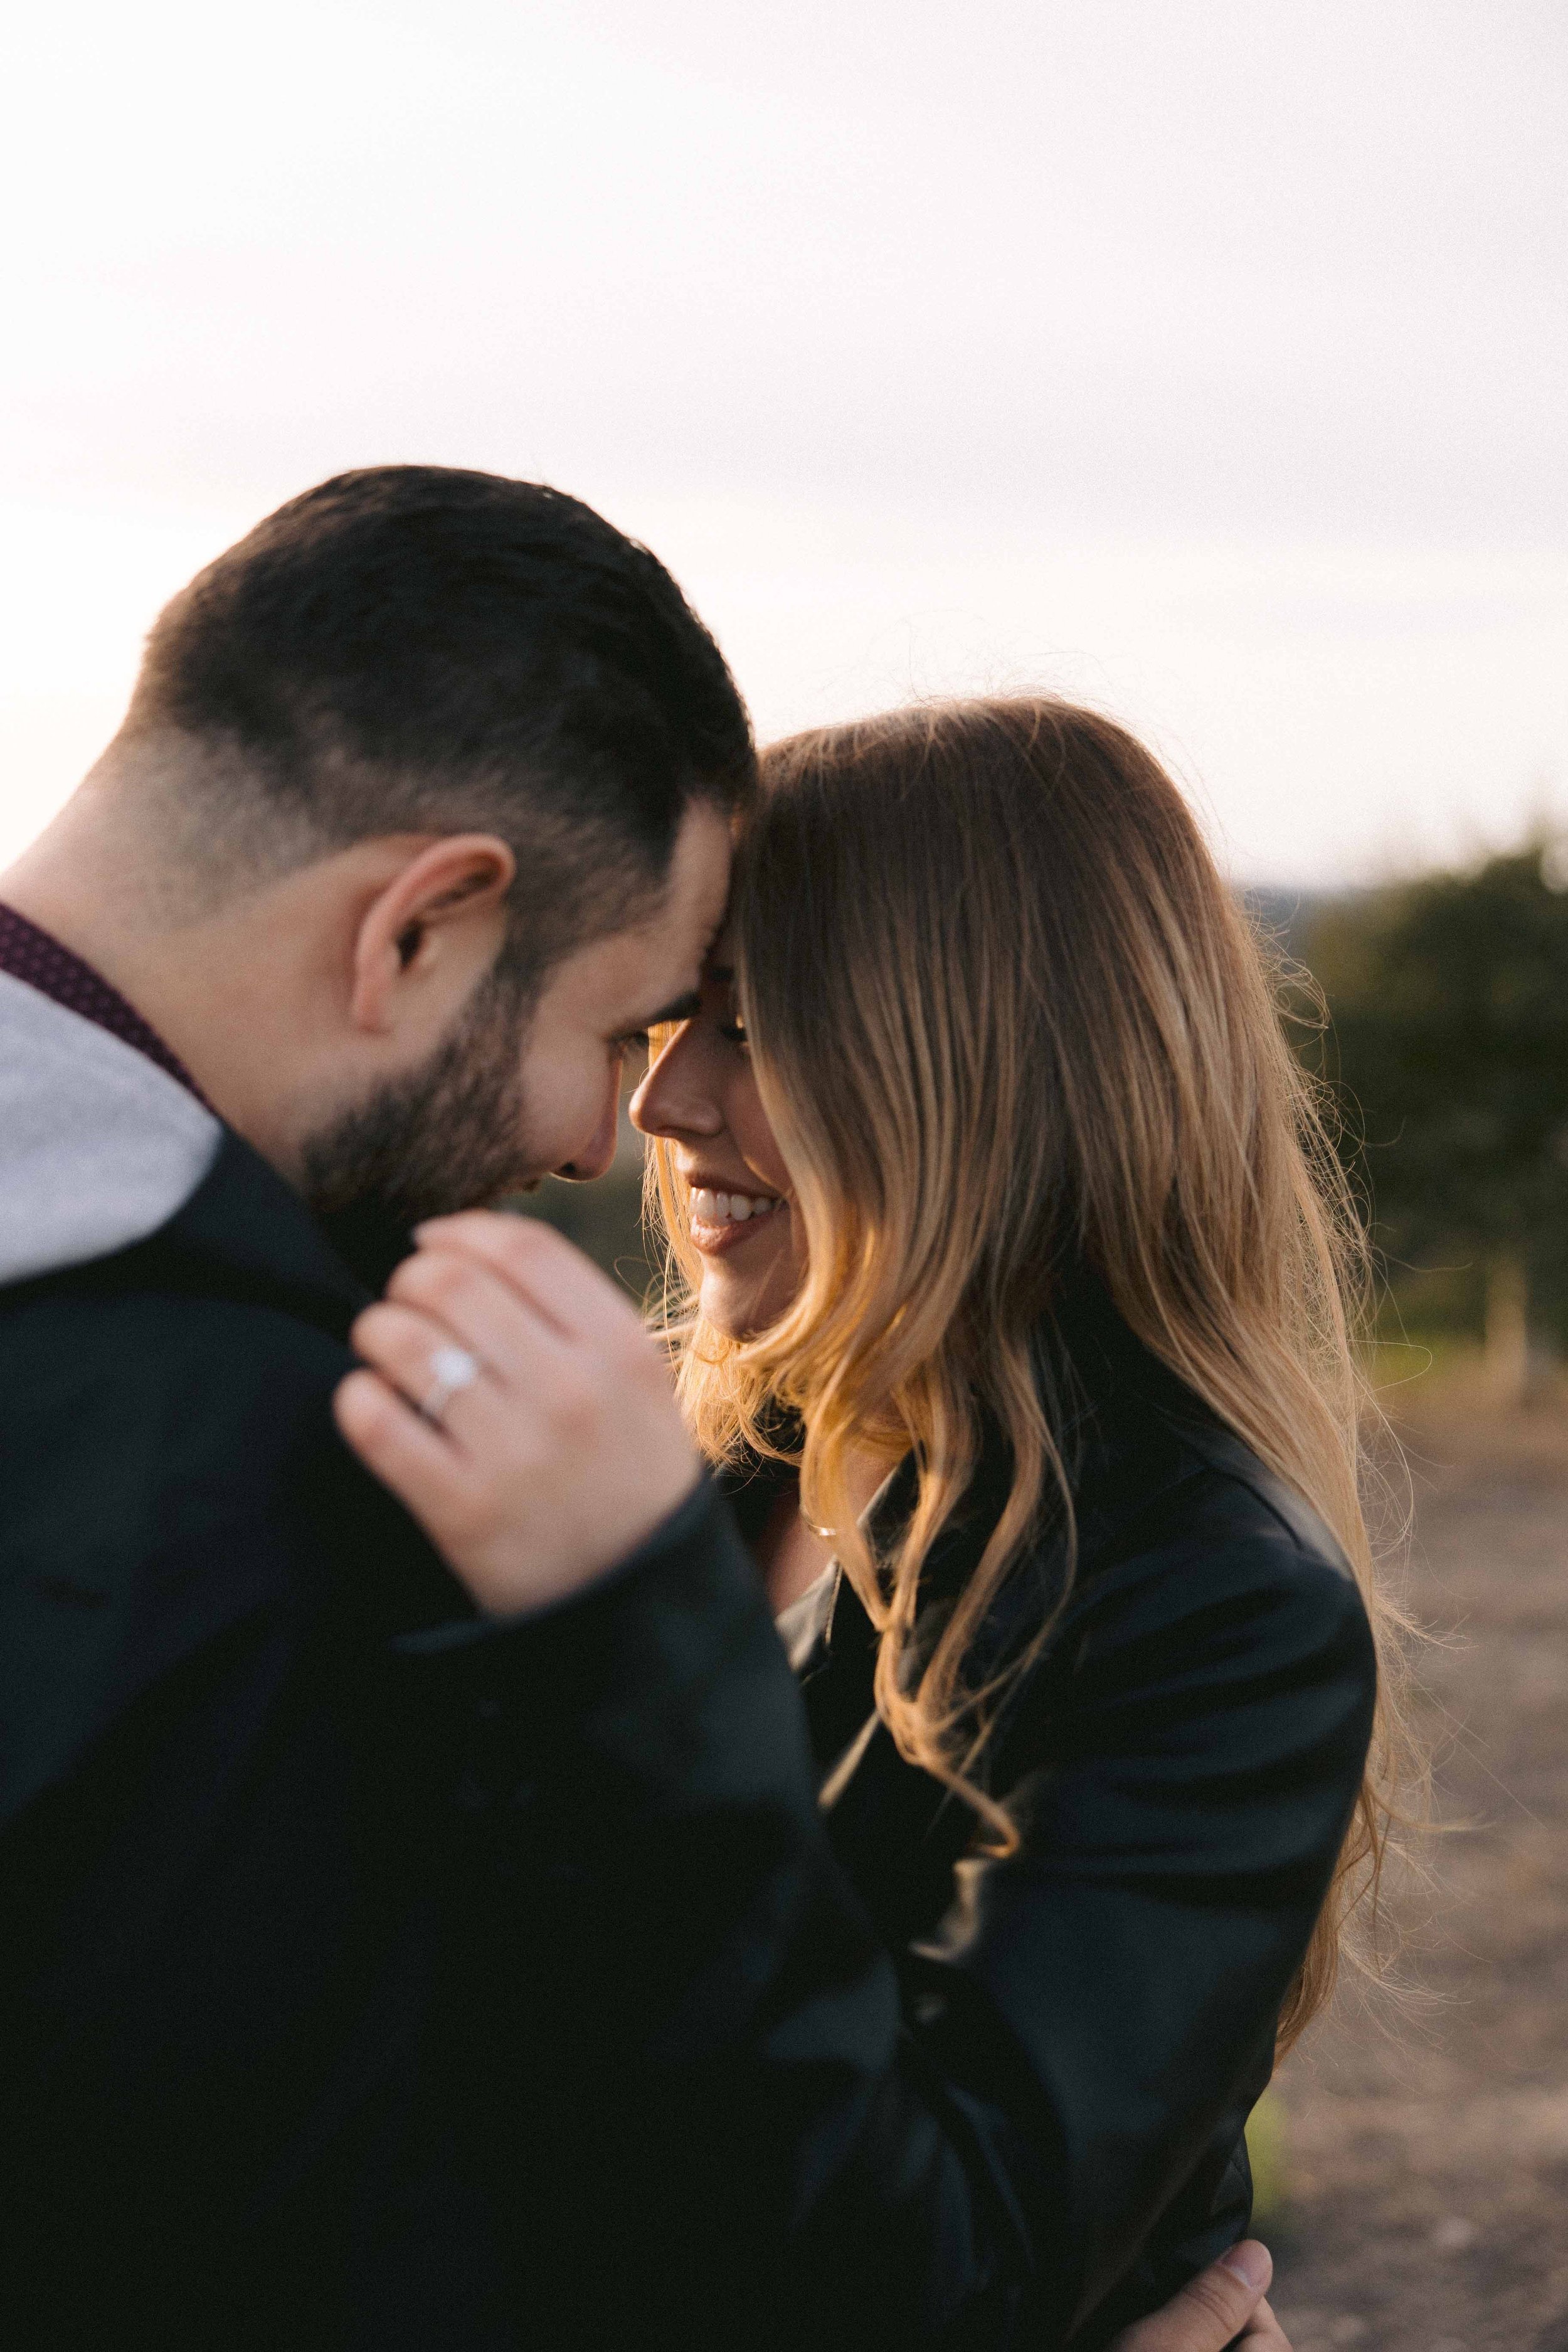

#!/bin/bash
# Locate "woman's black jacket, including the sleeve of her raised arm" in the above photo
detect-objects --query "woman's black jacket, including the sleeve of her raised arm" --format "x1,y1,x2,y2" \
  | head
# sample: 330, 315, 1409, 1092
405, 1491, 1373, 2352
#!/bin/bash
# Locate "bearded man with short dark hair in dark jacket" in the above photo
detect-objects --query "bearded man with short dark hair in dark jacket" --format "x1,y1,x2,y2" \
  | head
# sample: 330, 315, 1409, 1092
0, 468, 1267, 2352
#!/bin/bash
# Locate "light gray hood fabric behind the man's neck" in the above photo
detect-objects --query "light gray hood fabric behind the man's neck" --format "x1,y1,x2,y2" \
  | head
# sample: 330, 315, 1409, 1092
0, 972, 223, 1282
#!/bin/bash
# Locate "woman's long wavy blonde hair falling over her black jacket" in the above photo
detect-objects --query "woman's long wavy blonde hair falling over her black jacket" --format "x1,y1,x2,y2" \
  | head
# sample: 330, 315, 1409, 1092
656, 699, 1406, 2044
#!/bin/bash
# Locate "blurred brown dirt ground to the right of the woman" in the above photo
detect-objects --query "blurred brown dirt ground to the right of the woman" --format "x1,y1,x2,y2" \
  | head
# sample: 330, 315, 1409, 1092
1260, 1383, 1568, 2352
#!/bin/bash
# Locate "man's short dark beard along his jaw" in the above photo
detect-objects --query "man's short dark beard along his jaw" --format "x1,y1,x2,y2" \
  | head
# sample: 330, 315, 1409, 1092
304, 972, 538, 1279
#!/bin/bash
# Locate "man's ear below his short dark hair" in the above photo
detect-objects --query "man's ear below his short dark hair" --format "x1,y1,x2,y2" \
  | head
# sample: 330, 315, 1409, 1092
348, 833, 517, 1032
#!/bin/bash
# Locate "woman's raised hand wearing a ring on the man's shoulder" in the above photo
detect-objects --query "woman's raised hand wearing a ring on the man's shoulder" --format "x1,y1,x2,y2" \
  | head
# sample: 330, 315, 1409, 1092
336, 1209, 698, 1616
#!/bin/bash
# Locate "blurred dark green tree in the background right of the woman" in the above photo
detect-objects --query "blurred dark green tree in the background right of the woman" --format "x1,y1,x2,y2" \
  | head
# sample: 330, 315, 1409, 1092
1293, 840, 1568, 1399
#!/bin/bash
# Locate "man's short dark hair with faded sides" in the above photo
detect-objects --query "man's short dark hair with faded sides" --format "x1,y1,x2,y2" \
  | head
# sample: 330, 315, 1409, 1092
125, 466, 755, 974
